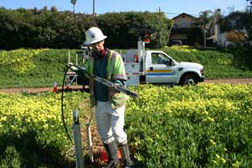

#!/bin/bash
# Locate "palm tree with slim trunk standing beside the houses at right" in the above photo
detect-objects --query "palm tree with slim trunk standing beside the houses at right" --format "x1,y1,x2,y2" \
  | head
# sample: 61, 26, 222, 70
198, 10, 213, 48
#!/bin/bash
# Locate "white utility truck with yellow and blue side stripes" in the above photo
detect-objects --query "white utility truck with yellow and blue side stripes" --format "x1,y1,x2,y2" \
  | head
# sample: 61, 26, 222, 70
122, 41, 204, 85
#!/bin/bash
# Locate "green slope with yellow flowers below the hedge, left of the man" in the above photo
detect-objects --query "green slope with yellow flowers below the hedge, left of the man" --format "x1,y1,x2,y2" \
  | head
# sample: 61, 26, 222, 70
0, 49, 75, 87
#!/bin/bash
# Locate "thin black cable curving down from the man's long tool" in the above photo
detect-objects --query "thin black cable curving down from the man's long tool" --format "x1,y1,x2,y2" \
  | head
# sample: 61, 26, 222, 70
61, 67, 74, 144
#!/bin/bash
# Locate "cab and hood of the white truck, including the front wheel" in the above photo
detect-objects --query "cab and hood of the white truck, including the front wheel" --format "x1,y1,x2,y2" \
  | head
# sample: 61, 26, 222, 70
145, 51, 204, 85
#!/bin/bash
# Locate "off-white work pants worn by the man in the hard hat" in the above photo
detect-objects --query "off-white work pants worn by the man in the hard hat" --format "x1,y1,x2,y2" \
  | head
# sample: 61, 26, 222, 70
95, 101, 127, 144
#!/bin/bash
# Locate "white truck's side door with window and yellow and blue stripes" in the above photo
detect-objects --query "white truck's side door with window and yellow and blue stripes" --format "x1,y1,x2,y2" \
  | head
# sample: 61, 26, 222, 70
146, 52, 177, 83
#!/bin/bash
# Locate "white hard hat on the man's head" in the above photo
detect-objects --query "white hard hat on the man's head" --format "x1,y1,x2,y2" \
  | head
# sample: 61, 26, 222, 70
85, 27, 107, 45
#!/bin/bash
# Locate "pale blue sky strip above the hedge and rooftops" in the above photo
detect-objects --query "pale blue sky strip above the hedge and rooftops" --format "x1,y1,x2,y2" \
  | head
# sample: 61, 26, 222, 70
0, 0, 248, 18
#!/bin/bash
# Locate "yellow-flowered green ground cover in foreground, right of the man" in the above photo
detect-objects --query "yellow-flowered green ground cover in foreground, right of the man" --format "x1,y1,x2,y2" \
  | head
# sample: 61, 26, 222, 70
126, 84, 252, 168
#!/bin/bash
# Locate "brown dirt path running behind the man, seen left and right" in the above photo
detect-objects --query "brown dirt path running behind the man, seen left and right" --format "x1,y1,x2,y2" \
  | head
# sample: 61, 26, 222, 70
0, 78, 252, 93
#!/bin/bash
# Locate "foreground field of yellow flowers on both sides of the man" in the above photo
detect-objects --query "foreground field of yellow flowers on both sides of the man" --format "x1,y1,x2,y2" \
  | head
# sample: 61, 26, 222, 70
0, 83, 252, 168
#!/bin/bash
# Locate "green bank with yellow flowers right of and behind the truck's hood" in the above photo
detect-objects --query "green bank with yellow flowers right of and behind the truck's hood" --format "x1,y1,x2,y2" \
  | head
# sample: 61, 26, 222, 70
163, 46, 252, 79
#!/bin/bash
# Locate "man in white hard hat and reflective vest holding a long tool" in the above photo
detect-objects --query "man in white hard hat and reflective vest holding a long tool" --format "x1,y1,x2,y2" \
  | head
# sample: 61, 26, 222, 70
85, 27, 132, 168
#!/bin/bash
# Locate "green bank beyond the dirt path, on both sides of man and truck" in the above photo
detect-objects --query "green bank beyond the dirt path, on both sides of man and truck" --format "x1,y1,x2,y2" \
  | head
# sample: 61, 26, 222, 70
0, 46, 252, 88
